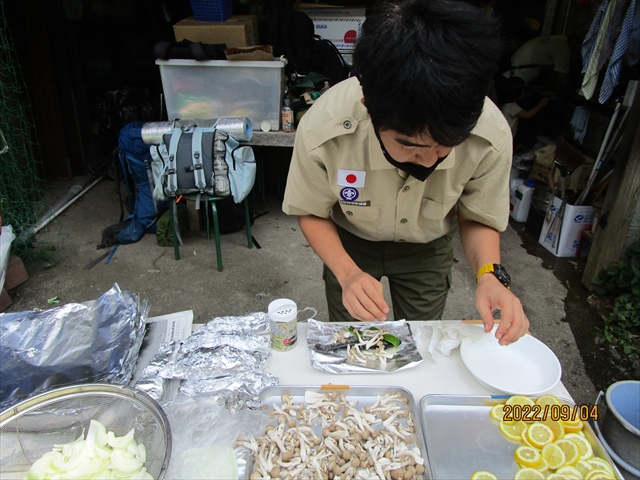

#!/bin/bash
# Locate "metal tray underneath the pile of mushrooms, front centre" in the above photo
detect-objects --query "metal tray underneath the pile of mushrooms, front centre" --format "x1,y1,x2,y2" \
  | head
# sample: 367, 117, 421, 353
238, 385, 431, 480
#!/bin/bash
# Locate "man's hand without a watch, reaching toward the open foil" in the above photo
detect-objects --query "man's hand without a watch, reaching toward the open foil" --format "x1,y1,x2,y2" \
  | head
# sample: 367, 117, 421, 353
342, 271, 389, 322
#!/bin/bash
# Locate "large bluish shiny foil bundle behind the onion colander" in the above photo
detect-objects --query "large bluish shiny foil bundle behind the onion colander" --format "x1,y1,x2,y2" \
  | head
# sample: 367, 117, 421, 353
0, 283, 149, 409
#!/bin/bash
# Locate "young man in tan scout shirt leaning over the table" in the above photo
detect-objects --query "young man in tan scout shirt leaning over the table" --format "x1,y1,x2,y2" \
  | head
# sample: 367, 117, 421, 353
283, 0, 529, 344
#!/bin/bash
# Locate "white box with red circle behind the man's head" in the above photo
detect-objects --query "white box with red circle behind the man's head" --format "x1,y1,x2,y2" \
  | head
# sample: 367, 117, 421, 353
303, 8, 366, 51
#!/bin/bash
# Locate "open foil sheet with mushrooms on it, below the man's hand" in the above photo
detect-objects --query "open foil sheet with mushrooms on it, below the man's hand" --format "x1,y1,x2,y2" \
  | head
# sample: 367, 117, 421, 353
307, 320, 423, 373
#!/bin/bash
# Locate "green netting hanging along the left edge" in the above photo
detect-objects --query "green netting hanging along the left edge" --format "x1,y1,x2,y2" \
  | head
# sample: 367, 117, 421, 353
0, 0, 48, 257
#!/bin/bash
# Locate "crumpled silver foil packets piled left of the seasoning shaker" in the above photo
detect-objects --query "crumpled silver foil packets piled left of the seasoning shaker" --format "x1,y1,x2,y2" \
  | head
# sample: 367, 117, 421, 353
135, 312, 279, 411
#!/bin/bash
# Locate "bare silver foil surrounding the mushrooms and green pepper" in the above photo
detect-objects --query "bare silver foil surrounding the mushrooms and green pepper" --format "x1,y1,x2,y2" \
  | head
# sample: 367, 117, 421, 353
307, 320, 423, 373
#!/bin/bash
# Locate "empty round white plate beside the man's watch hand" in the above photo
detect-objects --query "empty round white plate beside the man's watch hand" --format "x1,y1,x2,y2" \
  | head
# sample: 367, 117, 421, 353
460, 327, 562, 396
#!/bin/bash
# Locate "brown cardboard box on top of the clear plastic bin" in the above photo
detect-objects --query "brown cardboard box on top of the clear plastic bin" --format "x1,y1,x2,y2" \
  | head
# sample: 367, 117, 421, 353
173, 15, 258, 48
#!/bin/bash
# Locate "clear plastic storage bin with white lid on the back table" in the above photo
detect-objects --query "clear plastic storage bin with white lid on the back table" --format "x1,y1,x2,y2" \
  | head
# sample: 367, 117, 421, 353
156, 59, 285, 130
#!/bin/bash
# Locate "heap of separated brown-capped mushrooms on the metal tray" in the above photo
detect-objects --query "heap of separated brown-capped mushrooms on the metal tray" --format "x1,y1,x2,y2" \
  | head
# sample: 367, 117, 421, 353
236, 391, 425, 480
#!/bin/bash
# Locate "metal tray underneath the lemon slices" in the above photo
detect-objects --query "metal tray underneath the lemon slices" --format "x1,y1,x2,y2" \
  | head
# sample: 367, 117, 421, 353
419, 395, 623, 480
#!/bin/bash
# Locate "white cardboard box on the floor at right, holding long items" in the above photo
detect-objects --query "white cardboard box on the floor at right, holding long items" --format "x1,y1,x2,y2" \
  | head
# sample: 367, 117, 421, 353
538, 197, 595, 257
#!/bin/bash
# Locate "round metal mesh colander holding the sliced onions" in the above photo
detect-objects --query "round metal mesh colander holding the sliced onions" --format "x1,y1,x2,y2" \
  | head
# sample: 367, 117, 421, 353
0, 383, 171, 480
